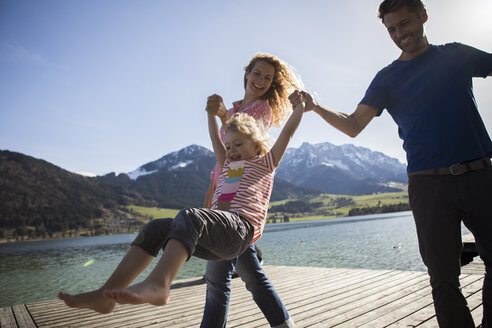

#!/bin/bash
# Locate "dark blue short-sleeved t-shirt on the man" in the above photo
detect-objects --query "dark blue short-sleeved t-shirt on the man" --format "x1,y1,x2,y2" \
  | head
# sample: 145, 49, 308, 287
360, 43, 492, 173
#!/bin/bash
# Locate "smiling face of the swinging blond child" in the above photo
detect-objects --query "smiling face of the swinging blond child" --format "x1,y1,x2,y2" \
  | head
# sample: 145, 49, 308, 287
224, 131, 260, 162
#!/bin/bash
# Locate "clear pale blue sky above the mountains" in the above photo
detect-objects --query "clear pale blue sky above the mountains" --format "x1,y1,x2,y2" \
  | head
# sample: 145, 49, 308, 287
0, 0, 492, 175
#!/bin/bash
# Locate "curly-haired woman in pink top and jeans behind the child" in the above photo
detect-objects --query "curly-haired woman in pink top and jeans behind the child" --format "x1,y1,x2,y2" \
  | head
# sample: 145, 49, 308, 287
201, 54, 302, 327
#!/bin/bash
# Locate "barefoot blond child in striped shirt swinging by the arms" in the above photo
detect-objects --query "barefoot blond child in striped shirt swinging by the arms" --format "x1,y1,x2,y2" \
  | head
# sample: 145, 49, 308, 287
59, 95, 304, 313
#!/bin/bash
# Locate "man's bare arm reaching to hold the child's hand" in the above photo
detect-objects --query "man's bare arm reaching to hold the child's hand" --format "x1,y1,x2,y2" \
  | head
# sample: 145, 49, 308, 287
289, 91, 378, 138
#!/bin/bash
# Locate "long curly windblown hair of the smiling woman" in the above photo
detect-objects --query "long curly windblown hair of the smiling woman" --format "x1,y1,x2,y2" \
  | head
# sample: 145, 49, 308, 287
244, 53, 302, 126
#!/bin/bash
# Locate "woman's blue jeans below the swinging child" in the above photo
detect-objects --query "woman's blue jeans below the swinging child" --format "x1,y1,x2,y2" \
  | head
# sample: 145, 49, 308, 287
200, 245, 289, 328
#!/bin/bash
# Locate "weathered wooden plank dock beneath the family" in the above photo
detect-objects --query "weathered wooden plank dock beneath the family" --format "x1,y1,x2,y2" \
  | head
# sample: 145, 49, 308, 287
0, 262, 484, 328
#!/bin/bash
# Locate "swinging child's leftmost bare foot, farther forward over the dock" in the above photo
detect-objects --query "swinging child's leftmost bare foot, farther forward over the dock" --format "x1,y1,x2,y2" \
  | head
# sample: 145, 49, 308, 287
58, 290, 116, 313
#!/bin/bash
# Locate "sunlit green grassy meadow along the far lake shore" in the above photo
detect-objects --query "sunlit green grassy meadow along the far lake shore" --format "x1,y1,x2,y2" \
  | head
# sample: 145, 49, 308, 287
128, 191, 408, 222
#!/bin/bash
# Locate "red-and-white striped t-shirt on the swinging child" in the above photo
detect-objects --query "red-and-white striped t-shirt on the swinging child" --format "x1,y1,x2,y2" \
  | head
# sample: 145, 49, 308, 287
211, 152, 276, 243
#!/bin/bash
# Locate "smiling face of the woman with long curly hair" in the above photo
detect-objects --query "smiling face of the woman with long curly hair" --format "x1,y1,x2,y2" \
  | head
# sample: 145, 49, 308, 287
245, 60, 275, 98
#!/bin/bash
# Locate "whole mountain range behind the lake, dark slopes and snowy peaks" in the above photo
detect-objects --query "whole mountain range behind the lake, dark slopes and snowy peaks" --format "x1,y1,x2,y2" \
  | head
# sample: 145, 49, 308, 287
0, 142, 407, 238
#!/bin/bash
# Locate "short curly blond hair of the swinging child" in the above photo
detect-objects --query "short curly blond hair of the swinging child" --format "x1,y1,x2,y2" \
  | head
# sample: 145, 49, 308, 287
224, 113, 270, 156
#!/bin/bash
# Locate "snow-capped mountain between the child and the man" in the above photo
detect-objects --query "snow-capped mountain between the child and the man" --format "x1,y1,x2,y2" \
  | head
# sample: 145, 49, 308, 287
277, 142, 407, 194
